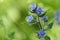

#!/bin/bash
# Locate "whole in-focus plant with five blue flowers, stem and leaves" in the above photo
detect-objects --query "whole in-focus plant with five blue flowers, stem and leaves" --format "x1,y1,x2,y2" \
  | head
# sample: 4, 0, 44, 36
26, 4, 53, 40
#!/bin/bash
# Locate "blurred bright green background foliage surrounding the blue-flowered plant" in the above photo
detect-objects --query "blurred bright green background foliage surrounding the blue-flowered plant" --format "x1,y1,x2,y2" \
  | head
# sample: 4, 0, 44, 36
0, 0, 60, 40
